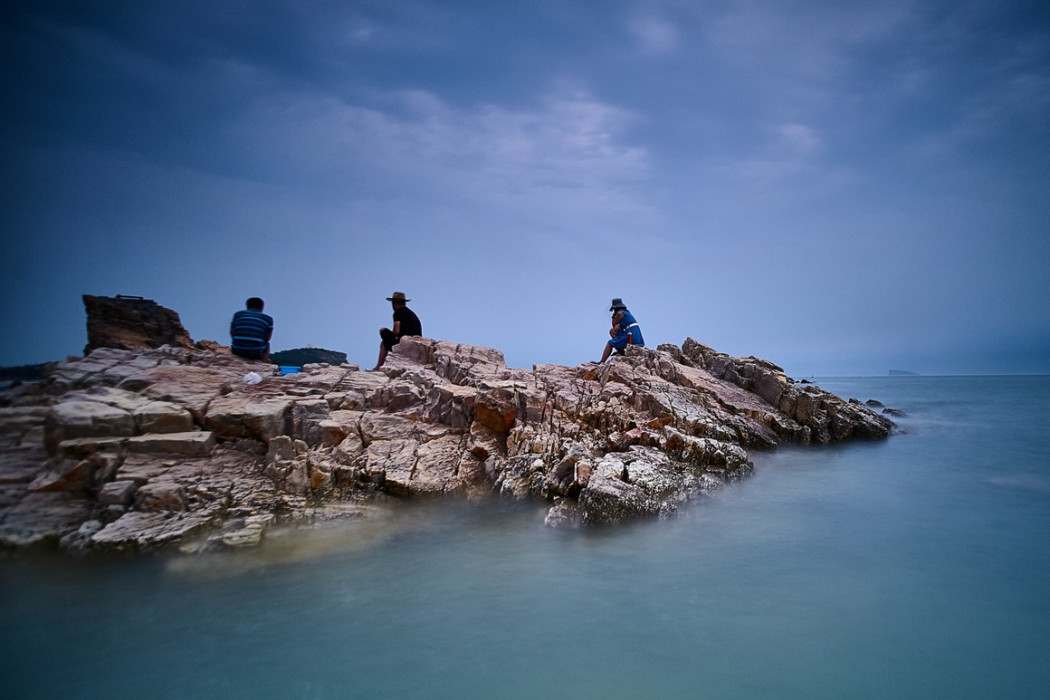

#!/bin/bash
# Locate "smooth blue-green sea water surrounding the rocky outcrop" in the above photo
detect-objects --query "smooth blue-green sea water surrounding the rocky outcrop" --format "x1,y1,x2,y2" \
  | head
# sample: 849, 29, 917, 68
0, 376, 1050, 700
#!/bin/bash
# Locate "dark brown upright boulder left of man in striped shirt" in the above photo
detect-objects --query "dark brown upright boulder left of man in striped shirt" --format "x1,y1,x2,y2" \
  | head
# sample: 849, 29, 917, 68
84, 294, 193, 355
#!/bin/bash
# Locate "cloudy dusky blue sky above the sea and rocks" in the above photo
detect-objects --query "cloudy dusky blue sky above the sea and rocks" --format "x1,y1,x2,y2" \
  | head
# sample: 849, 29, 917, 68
0, 0, 1050, 377
